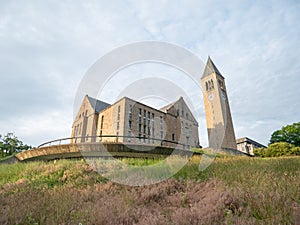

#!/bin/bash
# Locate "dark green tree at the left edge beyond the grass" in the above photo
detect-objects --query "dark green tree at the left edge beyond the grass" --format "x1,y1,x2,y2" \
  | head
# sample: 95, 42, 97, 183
0, 133, 31, 158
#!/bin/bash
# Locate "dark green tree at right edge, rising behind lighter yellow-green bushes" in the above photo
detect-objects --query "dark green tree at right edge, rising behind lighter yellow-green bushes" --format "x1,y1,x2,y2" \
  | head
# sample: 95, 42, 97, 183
270, 122, 300, 146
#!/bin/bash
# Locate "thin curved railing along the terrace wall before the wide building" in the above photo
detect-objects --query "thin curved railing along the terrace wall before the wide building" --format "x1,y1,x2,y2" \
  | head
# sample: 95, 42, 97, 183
37, 135, 190, 149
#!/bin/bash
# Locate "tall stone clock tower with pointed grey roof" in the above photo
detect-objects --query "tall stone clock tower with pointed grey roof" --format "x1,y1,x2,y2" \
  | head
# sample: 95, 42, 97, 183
201, 57, 237, 149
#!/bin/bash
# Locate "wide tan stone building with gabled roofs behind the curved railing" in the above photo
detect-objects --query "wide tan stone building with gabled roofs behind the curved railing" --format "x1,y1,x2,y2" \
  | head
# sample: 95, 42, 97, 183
72, 95, 200, 148
